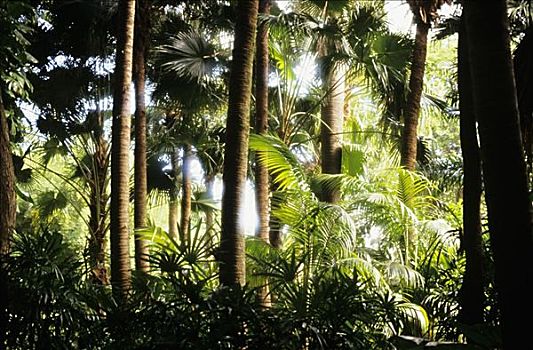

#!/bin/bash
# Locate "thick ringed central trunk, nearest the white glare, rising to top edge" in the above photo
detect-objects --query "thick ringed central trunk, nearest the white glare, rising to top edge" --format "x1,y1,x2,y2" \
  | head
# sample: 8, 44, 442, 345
219, 0, 258, 285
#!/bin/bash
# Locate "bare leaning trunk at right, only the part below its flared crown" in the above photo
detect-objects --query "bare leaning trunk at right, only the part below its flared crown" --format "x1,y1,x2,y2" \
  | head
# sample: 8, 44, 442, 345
400, 22, 430, 170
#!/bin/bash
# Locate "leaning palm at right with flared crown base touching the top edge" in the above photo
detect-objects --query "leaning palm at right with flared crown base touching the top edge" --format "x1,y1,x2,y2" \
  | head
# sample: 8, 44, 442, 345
400, 0, 450, 170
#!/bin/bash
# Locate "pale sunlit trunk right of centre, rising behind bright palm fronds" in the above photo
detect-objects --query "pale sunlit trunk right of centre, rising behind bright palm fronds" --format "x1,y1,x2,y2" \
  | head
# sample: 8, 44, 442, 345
320, 65, 345, 203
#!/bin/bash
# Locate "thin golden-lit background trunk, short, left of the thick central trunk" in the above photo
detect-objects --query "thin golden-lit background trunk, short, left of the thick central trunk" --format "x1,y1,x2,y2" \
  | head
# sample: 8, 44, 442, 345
180, 144, 192, 242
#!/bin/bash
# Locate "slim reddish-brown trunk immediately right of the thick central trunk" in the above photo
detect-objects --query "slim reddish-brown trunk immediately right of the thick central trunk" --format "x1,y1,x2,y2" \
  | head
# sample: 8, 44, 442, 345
255, 0, 271, 242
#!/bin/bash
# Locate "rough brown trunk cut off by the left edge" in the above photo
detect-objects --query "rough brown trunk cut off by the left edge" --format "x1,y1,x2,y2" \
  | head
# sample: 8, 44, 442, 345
0, 89, 17, 256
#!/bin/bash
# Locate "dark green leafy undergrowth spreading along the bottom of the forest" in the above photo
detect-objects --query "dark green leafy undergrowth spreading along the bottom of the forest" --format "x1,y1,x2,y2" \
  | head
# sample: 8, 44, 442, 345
1, 232, 498, 349
